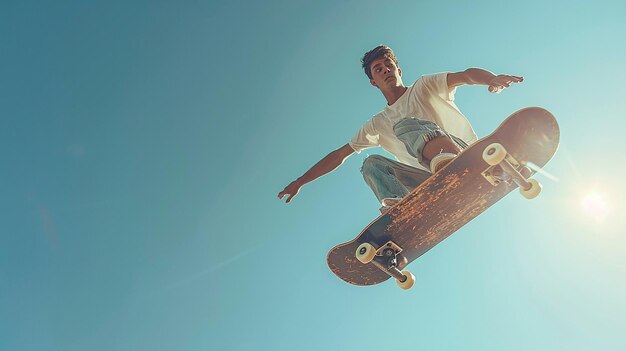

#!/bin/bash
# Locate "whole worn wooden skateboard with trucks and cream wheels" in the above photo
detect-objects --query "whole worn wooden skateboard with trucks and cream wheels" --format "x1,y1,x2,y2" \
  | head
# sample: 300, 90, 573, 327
326, 107, 560, 289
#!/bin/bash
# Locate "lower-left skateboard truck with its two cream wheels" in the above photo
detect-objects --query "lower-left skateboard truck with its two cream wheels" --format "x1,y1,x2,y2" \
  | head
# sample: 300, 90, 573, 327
355, 241, 415, 290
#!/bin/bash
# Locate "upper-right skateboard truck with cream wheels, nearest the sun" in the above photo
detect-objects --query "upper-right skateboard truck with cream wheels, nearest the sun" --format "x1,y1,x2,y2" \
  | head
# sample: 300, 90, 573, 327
482, 143, 541, 199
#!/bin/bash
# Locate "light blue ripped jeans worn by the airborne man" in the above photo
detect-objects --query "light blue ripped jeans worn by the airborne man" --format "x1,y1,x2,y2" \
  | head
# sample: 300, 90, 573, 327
361, 118, 468, 202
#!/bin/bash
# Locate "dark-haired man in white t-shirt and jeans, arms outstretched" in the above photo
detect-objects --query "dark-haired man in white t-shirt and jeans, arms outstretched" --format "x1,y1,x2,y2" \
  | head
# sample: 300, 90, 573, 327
278, 45, 524, 213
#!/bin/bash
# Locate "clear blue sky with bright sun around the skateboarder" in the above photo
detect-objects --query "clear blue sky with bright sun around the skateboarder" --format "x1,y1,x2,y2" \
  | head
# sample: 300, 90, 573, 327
0, 1, 626, 351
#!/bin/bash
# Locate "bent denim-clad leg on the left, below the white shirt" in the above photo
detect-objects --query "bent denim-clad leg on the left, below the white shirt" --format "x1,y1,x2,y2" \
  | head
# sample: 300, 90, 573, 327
361, 155, 431, 210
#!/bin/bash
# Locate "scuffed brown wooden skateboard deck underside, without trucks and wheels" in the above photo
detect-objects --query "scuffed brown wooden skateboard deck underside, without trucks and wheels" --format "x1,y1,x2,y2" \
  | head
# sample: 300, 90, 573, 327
327, 107, 559, 285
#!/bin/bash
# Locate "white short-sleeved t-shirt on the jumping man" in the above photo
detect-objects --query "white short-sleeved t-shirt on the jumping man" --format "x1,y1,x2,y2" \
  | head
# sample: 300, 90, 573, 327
349, 73, 477, 169
